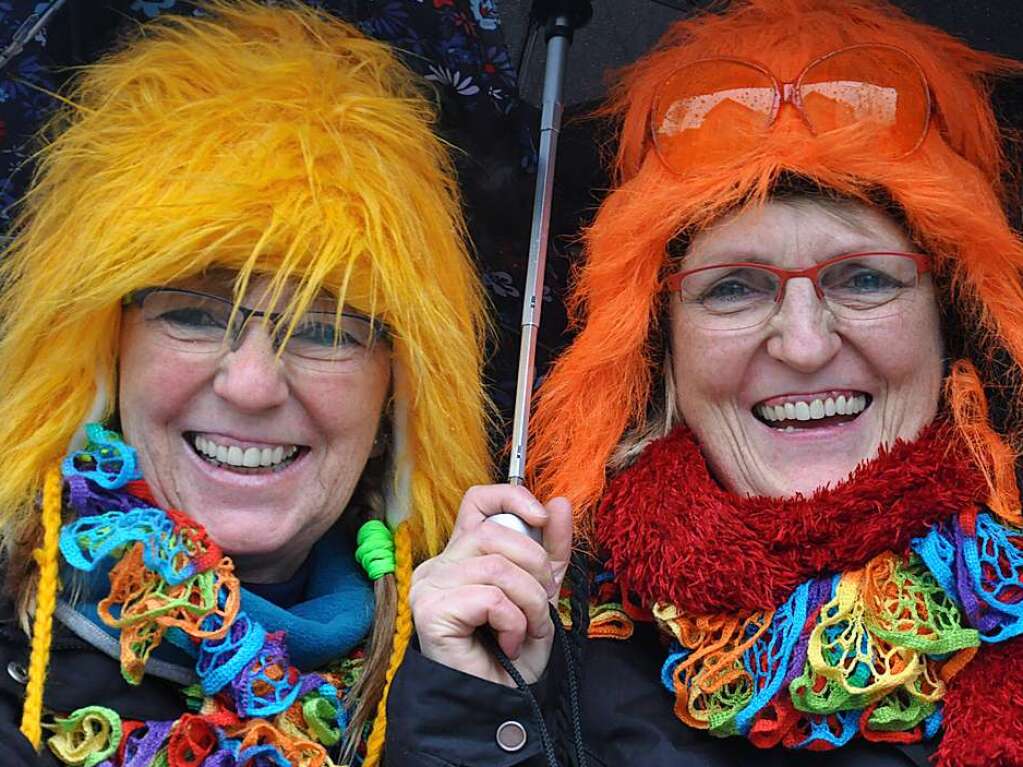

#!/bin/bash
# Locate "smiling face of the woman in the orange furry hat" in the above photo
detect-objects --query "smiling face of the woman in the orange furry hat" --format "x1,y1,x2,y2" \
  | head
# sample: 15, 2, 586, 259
670, 198, 942, 497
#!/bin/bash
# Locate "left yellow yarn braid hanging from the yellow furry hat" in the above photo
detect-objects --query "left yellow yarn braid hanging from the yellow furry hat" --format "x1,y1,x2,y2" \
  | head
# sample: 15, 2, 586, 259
21, 466, 61, 749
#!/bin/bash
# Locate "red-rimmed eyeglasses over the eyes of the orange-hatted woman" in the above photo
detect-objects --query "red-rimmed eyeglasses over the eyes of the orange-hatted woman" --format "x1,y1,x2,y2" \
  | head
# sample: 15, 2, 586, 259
666, 251, 931, 331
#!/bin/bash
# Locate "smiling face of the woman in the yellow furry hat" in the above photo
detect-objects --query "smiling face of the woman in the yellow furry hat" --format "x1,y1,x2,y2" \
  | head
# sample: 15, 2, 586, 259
119, 276, 391, 582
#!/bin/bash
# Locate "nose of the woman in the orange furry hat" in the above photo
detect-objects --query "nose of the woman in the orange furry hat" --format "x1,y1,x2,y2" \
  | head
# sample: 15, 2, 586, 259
767, 278, 842, 373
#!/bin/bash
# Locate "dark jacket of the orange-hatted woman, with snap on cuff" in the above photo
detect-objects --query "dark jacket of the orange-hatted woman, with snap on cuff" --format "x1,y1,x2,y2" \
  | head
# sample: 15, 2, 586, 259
385, 624, 934, 767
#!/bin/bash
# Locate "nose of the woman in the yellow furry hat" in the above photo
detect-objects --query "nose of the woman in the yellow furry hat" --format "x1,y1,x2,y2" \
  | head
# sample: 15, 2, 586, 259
213, 322, 291, 412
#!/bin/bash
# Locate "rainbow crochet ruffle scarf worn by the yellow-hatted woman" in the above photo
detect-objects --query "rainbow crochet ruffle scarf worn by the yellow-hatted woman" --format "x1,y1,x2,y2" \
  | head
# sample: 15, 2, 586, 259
47, 424, 370, 767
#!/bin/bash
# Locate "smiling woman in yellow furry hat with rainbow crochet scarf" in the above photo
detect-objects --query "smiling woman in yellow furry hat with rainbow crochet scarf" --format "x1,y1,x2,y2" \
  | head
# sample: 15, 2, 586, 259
0, 0, 488, 767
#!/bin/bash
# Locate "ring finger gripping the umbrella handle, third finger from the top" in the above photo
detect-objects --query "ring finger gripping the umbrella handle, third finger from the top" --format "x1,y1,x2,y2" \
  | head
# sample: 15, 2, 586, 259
429, 554, 550, 639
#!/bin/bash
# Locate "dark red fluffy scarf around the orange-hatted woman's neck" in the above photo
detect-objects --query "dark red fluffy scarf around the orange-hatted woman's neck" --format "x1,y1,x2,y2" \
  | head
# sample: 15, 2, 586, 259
595, 425, 1023, 767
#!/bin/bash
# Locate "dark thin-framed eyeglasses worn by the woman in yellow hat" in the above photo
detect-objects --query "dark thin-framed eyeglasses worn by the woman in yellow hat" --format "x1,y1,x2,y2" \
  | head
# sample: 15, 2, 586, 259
125, 287, 389, 370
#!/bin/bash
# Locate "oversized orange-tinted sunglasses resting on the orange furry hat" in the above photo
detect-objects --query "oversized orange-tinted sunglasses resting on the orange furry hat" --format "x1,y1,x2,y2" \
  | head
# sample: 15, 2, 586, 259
650, 43, 933, 175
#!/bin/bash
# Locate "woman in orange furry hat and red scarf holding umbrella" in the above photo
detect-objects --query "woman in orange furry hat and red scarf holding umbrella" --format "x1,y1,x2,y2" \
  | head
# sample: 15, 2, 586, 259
392, 0, 1023, 767
